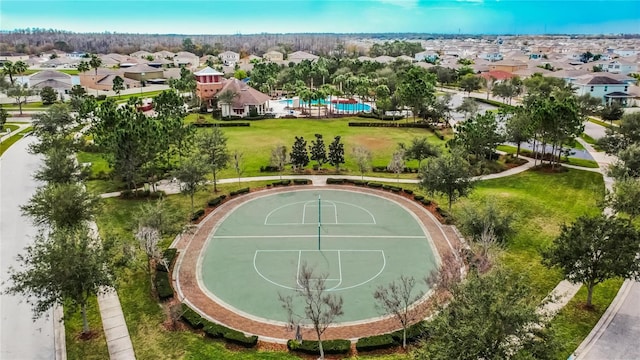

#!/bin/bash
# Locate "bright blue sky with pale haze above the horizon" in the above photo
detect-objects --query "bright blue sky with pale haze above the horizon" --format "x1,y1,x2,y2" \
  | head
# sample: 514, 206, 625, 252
0, 0, 640, 34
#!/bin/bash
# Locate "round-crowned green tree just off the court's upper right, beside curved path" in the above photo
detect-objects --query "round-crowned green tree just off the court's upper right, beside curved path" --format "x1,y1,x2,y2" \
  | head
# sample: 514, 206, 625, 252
419, 152, 473, 211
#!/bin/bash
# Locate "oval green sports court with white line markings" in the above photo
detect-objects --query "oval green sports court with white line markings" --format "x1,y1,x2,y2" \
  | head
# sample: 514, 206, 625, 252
196, 188, 439, 323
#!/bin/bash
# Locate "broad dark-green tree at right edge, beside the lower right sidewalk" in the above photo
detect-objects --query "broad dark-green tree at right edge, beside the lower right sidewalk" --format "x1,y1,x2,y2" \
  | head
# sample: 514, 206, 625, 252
543, 214, 640, 306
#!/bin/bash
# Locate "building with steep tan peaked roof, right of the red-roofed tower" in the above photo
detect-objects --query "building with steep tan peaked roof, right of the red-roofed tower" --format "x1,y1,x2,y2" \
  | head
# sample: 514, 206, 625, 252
216, 78, 270, 117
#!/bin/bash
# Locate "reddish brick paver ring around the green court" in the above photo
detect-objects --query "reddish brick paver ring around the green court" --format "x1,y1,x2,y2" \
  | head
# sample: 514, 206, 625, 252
173, 185, 460, 343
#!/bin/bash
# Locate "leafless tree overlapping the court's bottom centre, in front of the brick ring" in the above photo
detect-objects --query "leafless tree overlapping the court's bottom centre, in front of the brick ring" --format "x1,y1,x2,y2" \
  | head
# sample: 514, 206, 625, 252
278, 263, 343, 359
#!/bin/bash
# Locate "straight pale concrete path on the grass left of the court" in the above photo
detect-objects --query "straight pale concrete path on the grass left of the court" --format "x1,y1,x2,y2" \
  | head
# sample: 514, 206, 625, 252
89, 221, 136, 360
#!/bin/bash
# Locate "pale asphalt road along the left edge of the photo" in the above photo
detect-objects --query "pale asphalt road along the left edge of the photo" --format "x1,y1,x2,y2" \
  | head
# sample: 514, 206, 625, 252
0, 136, 55, 360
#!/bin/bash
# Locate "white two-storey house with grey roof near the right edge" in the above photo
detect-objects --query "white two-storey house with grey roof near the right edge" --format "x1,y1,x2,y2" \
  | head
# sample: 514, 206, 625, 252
571, 74, 633, 106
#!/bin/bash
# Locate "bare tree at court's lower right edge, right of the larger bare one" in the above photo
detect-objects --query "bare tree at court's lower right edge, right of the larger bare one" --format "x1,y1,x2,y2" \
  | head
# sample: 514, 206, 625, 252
373, 275, 422, 349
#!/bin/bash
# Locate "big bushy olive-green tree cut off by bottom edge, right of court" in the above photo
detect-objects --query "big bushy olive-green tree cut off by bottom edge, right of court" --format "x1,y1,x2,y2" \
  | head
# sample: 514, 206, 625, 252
415, 270, 559, 360
